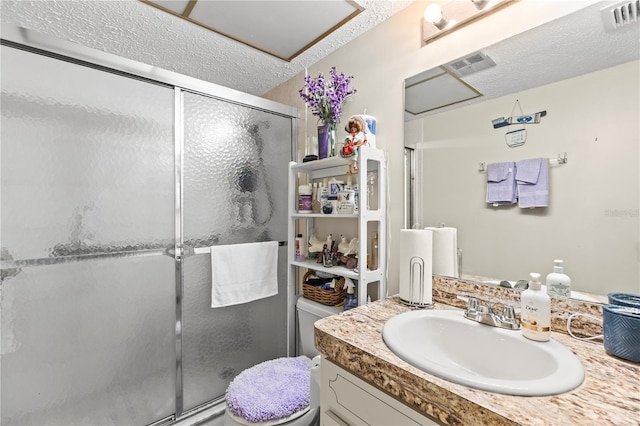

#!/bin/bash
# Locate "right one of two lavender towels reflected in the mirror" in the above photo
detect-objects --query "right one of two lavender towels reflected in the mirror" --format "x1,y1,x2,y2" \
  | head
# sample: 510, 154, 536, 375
516, 158, 549, 209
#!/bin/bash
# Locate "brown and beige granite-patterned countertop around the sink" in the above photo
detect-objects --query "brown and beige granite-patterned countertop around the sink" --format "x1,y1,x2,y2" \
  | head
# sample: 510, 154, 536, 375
315, 298, 640, 426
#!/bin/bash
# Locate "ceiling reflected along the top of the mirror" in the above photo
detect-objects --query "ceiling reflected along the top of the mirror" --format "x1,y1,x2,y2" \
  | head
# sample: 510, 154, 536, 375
405, 1, 640, 121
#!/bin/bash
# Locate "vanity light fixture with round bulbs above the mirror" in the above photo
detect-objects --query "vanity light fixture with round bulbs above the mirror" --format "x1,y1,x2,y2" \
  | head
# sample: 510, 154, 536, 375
422, 0, 518, 46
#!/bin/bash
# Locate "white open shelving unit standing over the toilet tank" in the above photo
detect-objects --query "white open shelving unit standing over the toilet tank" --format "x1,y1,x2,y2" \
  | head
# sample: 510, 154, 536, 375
288, 146, 387, 305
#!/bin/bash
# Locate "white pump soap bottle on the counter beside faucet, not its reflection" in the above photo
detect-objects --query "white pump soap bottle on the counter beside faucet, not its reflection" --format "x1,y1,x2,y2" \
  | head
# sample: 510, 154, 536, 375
520, 272, 551, 342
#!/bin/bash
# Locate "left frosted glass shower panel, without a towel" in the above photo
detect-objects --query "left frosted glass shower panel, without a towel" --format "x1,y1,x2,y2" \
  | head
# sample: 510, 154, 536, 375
0, 46, 176, 426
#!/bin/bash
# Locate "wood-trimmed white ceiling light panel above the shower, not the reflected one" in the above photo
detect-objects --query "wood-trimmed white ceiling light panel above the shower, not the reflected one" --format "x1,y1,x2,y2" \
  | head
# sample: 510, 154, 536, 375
140, 0, 362, 61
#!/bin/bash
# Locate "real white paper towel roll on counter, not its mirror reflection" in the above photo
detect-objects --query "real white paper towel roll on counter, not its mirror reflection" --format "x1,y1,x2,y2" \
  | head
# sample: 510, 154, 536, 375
399, 229, 433, 306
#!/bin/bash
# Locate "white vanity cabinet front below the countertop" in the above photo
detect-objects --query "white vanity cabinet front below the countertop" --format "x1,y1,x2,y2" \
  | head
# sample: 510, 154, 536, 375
320, 356, 438, 426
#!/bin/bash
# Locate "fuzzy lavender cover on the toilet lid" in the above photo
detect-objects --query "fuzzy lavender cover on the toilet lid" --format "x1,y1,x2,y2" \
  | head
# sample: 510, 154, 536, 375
226, 356, 311, 422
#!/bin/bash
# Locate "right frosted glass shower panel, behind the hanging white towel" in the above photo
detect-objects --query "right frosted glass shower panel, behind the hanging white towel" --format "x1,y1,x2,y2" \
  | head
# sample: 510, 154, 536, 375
182, 92, 292, 411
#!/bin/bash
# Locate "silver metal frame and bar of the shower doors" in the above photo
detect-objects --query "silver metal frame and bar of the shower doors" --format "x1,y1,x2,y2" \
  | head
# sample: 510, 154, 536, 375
0, 25, 298, 424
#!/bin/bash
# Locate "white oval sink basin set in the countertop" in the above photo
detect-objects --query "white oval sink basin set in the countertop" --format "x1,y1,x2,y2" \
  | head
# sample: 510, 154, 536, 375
382, 310, 584, 396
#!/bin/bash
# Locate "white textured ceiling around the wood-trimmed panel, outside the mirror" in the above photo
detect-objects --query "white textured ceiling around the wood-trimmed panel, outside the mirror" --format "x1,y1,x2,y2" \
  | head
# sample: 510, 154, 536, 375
0, 0, 412, 96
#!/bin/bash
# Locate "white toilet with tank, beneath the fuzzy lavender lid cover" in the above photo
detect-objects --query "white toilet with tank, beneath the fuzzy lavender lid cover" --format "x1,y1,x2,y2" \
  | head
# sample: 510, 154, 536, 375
224, 297, 342, 426
